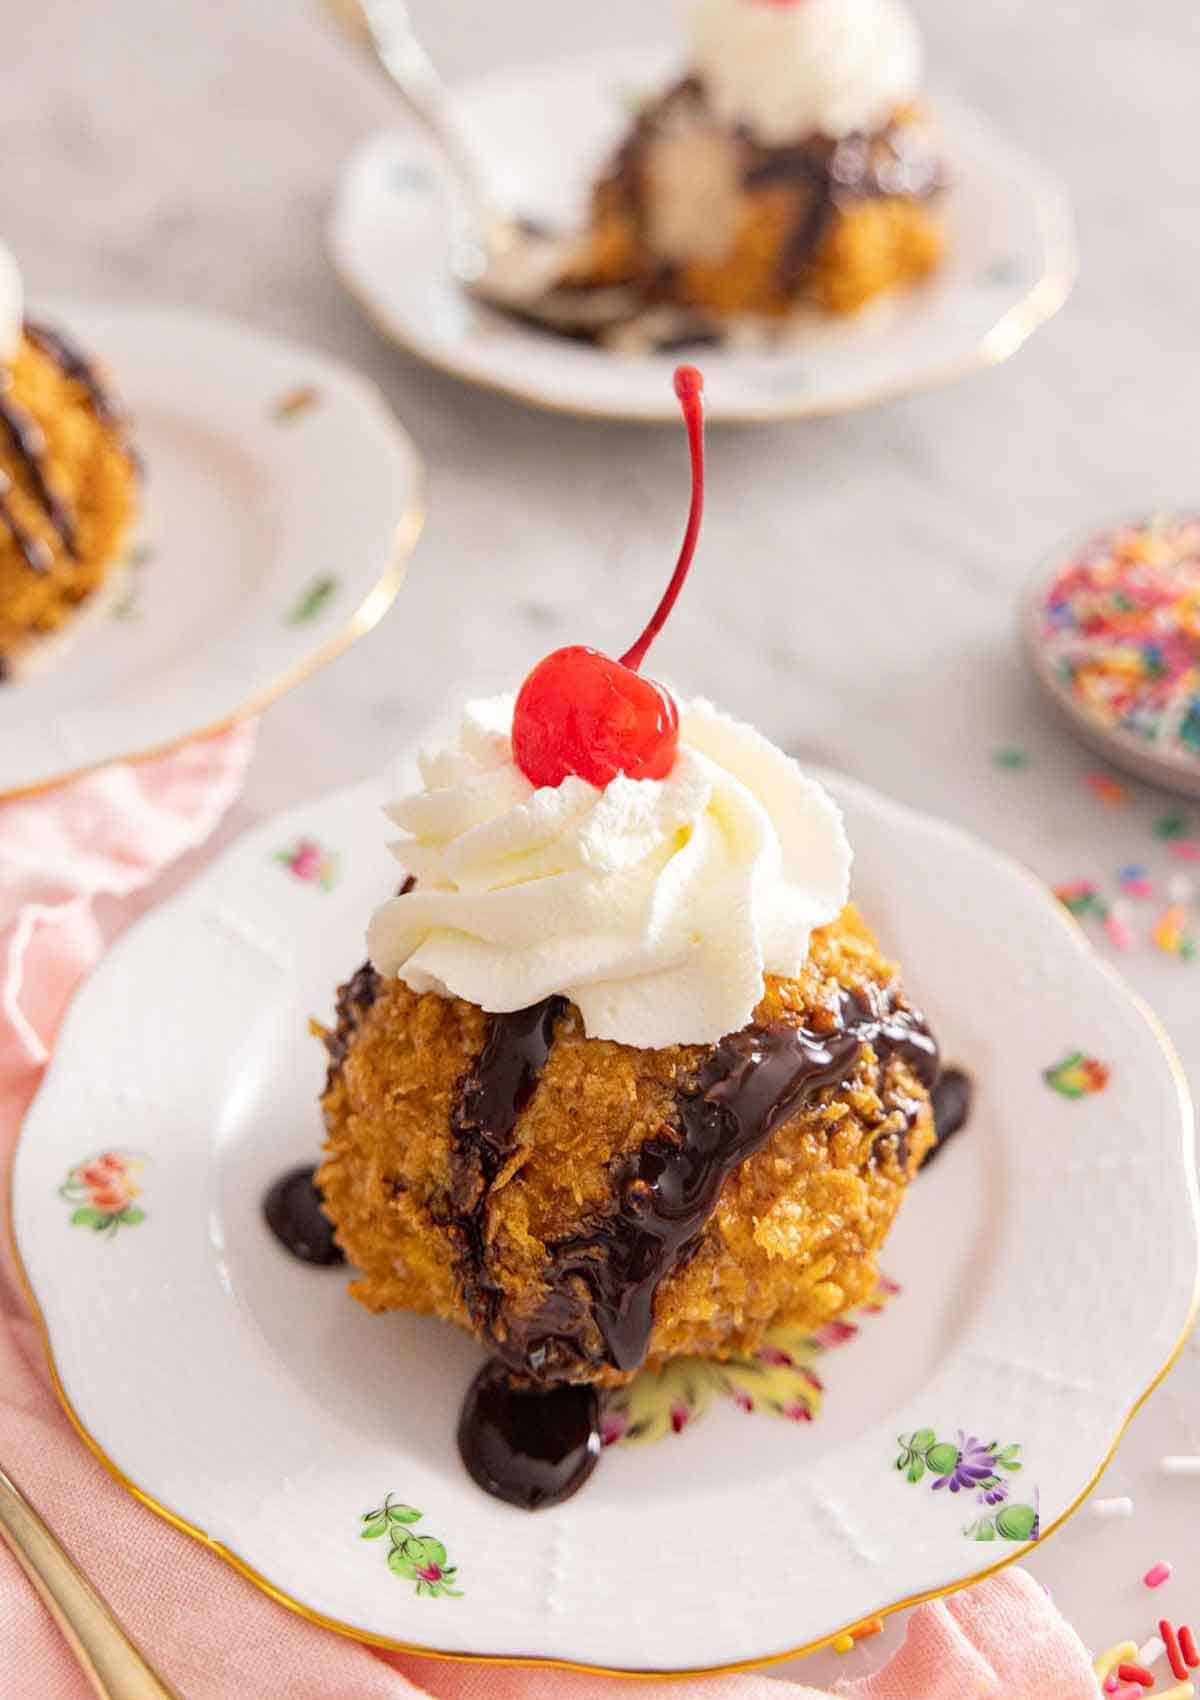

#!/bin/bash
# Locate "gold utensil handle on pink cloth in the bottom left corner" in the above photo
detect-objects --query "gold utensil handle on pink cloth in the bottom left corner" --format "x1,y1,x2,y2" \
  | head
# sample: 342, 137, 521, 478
0, 1471, 180, 1700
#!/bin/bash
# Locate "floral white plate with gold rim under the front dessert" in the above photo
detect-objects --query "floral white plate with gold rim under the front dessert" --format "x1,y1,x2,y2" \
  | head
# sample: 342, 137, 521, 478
12, 780, 1197, 1673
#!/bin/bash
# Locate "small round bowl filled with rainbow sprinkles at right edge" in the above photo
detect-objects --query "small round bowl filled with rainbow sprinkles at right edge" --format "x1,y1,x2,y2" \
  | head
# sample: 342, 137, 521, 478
1040, 515, 1200, 765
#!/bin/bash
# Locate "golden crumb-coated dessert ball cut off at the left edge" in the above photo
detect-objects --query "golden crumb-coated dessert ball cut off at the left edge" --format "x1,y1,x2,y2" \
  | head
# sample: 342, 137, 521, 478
0, 337, 138, 663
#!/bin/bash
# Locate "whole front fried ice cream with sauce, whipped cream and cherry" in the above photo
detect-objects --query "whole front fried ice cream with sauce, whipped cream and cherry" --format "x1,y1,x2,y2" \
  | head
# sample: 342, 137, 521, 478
305, 367, 938, 1508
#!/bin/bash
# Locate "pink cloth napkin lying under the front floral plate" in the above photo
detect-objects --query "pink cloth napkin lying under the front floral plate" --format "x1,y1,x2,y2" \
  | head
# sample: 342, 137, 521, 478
0, 744, 1096, 1700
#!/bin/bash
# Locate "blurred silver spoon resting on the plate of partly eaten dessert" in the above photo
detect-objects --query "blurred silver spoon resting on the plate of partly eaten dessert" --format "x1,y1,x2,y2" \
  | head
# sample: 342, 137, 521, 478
323, 0, 636, 335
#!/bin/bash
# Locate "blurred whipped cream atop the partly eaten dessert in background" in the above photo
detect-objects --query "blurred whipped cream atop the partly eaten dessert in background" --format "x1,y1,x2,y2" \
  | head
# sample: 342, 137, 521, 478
687, 0, 923, 145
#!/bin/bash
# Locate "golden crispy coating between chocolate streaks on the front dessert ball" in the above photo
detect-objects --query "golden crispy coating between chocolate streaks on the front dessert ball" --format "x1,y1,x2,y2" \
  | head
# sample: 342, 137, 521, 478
318, 908, 935, 1384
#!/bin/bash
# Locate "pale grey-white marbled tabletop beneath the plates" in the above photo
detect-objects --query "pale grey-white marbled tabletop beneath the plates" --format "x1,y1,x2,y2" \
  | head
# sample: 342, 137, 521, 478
0, 0, 1200, 1681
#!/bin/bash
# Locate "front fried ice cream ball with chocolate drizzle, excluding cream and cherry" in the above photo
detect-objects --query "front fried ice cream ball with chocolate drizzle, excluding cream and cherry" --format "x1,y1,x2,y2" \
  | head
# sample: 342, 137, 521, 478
318, 908, 937, 1386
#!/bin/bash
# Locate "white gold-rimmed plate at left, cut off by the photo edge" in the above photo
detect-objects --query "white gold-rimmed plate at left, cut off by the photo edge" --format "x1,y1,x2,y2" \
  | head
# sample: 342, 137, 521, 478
0, 301, 425, 801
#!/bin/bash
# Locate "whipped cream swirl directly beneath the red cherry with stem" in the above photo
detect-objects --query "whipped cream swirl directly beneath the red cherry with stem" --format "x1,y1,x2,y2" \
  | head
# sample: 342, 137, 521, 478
367, 697, 850, 1047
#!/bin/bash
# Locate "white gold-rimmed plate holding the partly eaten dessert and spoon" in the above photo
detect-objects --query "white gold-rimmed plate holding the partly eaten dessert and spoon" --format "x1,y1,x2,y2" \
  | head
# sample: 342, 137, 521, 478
328, 54, 1076, 422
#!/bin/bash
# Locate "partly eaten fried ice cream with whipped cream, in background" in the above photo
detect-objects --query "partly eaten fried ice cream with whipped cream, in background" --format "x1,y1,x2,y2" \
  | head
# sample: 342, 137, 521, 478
563, 0, 943, 325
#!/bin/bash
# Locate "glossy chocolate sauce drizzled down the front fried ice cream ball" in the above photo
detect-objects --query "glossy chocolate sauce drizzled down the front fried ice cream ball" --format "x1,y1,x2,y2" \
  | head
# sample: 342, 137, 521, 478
450, 986, 938, 1382
